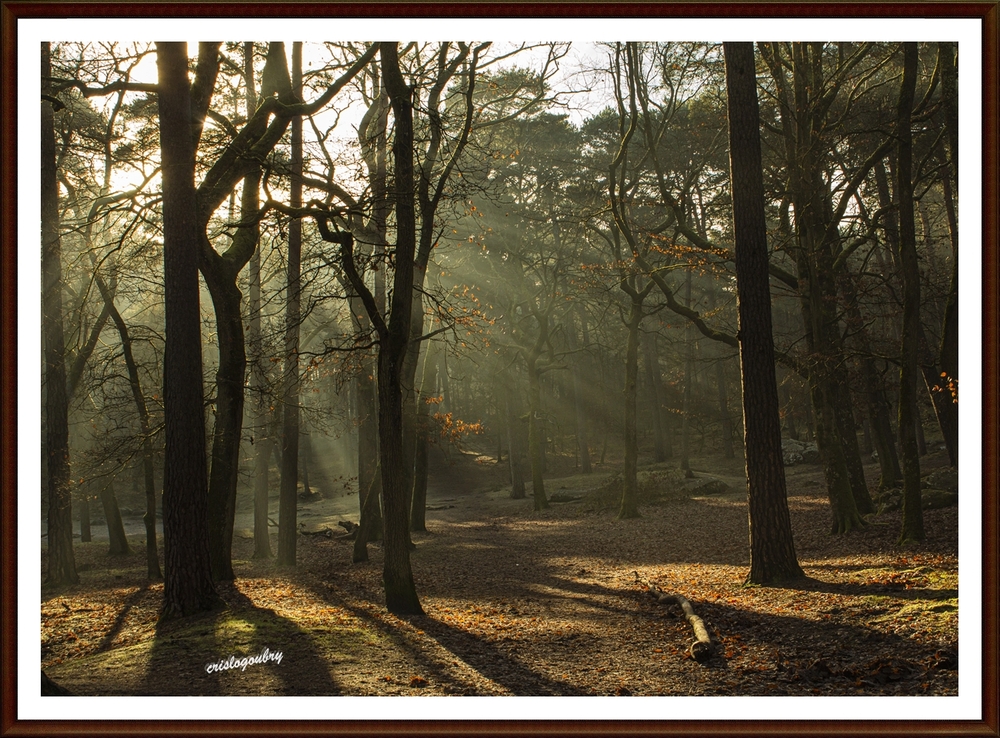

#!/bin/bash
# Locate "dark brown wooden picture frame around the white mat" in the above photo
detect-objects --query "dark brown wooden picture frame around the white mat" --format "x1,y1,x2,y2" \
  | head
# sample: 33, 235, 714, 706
0, 0, 1000, 738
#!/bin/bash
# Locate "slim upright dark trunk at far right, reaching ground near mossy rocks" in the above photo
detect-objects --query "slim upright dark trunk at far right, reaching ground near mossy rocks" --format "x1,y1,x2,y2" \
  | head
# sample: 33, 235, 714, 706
896, 42, 924, 543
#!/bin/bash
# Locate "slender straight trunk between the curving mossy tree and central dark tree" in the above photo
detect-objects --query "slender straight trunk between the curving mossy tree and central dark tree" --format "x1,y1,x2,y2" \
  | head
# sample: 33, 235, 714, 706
277, 41, 302, 566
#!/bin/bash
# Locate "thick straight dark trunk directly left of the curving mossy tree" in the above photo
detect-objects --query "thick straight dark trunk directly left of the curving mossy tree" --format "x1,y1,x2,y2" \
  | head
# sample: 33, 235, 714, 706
156, 42, 219, 619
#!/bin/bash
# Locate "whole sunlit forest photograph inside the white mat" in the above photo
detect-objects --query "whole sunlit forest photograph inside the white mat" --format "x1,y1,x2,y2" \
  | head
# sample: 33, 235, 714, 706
37, 41, 960, 704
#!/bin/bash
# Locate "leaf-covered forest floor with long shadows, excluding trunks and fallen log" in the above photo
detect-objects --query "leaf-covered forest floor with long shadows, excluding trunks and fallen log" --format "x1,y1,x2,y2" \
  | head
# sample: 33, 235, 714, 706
41, 452, 958, 695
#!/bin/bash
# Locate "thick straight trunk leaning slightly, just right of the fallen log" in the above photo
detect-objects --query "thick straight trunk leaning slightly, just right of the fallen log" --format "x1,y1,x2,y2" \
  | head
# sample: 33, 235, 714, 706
724, 43, 802, 584
